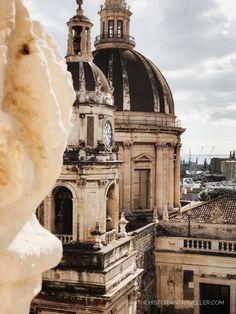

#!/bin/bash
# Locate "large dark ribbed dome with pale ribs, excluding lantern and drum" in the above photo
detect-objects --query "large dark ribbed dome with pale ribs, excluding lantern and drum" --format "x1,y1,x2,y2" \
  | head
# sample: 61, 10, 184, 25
93, 48, 174, 115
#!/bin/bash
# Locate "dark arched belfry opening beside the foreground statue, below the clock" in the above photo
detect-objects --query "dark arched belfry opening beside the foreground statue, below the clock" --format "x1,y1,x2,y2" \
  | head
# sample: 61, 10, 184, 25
53, 187, 73, 235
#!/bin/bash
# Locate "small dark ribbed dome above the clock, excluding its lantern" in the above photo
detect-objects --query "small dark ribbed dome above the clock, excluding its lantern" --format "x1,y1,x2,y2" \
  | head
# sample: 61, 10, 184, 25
67, 61, 113, 105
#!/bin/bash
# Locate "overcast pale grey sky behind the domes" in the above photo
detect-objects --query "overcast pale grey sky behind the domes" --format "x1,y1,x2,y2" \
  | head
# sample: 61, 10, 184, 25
25, 0, 236, 154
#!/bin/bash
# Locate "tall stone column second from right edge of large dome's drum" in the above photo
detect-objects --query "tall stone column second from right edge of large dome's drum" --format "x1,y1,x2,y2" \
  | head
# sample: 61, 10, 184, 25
168, 143, 174, 208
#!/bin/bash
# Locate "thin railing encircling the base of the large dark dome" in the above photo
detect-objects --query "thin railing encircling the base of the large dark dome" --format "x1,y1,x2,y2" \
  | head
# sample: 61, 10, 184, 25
115, 116, 181, 128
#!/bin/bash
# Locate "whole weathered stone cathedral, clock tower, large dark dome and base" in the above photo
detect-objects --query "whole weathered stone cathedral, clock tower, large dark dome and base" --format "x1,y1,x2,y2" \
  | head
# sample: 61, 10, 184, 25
31, 0, 184, 314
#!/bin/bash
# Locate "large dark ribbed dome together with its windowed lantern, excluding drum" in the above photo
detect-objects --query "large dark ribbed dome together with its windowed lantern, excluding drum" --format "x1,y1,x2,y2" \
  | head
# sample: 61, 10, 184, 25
93, 0, 175, 115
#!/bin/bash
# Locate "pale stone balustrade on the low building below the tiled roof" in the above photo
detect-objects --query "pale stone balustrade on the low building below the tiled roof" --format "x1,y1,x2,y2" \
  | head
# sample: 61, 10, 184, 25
181, 238, 236, 254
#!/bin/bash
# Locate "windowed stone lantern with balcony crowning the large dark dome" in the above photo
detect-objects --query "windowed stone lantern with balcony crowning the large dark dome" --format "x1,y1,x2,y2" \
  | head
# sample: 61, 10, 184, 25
95, 0, 135, 49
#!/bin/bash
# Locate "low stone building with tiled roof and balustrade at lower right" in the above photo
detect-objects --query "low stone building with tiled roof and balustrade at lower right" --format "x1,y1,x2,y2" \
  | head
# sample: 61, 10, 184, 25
155, 197, 236, 314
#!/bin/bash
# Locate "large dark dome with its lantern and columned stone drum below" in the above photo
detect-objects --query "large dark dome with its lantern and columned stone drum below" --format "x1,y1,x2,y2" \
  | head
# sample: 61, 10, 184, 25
94, 1, 184, 214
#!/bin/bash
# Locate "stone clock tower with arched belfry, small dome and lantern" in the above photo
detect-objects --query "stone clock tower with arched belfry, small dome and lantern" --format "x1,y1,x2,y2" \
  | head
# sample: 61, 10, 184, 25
44, 0, 121, 245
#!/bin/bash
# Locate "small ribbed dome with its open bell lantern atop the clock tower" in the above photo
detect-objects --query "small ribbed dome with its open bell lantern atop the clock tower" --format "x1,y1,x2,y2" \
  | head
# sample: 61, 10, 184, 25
66, 0, 113, 105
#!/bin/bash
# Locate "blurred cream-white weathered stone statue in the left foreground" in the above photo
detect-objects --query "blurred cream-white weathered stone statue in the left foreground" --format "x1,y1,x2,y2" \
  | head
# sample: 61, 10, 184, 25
0, 0, 75, 314
